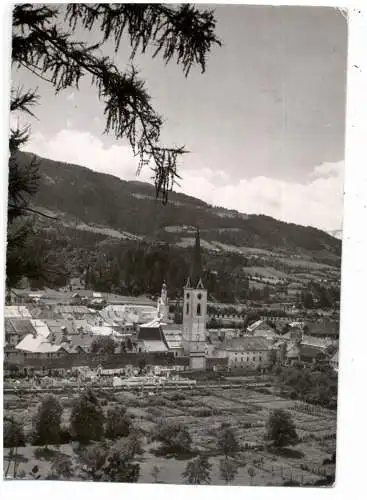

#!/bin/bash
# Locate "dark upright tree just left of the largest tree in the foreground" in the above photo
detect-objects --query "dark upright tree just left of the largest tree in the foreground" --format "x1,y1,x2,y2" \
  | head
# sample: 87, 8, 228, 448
33, 396, 63, 447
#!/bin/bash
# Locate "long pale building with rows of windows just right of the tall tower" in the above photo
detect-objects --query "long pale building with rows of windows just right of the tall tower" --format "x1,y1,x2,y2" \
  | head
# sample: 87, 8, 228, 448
216, 336, 271, 369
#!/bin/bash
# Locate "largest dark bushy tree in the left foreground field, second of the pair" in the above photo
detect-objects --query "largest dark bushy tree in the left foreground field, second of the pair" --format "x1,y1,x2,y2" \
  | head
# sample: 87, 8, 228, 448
70, 392, 104, 443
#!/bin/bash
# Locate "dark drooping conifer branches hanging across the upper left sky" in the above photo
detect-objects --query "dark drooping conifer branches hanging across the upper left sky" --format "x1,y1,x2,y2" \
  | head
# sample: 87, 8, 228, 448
12, 4, 220, 202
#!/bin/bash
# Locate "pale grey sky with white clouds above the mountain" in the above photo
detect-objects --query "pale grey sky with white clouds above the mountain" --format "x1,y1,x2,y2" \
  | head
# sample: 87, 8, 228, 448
12, 5, 348, 230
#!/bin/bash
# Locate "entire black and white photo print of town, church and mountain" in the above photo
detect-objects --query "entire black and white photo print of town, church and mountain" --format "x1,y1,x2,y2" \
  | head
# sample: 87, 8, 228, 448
2, 3, 348, 488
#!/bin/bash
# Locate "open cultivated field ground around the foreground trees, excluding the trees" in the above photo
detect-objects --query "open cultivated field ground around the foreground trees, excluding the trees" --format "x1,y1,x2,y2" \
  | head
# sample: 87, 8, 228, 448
4, 386, 336, 485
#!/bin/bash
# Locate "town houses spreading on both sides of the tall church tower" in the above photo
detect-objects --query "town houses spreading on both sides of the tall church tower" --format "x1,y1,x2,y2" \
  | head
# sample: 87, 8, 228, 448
4, 305, 338, 370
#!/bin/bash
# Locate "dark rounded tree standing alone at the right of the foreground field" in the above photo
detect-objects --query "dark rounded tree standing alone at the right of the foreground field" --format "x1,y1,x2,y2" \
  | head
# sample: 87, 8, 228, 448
265, 410, 298, 448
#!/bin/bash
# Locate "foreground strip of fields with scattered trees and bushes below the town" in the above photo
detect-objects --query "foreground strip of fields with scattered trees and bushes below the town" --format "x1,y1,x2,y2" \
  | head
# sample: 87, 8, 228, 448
4, 380, 335, 484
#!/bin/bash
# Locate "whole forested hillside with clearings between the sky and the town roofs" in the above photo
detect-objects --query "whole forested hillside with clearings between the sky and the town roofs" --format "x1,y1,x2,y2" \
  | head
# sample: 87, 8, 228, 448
6, 153, 341, 301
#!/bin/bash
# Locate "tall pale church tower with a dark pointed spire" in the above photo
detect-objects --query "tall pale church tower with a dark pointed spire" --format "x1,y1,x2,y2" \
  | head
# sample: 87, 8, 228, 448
182, 230, 207, 370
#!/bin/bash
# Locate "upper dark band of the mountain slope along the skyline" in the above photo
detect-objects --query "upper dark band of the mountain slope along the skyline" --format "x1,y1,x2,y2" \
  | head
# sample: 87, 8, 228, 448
14, 152, 341, 265
